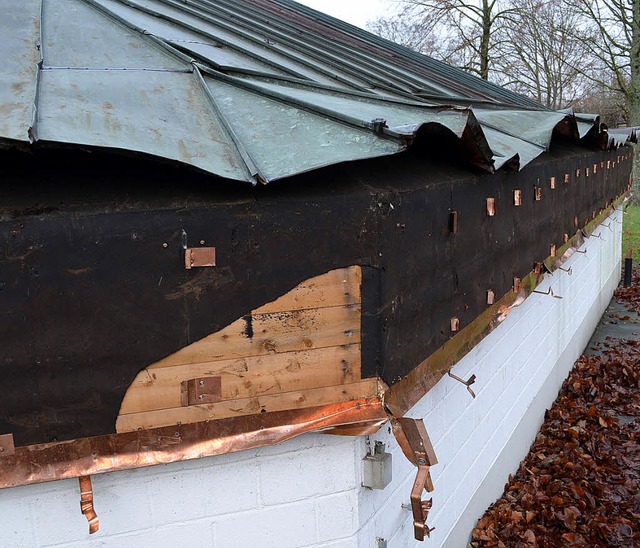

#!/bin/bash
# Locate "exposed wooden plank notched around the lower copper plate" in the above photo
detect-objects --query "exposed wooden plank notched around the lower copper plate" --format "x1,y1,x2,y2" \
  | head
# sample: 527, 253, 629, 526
120, 344, 361, 415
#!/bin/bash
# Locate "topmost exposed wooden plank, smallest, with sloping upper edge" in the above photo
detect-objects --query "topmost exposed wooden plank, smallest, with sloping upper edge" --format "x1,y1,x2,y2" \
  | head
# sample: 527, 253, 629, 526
253, 266, 362, 314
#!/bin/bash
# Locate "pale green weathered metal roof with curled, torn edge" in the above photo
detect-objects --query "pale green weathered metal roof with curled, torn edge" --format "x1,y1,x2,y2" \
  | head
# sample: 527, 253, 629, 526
0, 0, 632, 183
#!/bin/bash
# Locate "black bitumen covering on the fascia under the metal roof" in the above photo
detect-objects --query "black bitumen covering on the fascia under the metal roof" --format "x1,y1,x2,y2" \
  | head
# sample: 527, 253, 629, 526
0, 143, 631, 445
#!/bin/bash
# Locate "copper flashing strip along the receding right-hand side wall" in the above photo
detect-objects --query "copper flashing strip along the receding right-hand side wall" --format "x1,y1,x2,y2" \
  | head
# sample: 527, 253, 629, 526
384, 193, 626, 417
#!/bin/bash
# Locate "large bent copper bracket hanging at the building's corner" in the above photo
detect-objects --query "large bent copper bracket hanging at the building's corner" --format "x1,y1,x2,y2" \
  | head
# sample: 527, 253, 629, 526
391, 418, 438, 541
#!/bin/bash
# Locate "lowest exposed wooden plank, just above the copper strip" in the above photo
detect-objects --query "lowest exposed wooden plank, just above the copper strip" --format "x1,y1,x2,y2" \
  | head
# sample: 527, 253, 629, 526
116, 379, 382, 433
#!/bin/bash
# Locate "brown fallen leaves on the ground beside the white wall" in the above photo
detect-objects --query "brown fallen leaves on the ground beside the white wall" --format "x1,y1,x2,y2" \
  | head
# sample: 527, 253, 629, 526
471, 269, 640, 547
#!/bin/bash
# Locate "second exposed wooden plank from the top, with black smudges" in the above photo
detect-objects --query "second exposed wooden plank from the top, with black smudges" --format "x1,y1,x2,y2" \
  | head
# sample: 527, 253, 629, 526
147, 304, 361, 370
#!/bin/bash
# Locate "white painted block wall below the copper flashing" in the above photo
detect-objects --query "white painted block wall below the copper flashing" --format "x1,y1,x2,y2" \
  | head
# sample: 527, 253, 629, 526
0, 208, 622, 548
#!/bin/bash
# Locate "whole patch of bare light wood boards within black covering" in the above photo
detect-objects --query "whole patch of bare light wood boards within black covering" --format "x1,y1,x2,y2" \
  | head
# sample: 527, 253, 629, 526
116, 267, 381, 432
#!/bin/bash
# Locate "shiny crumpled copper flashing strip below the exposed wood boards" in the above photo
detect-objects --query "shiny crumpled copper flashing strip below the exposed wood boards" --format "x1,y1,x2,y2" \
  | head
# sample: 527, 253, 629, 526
0, 397, 388, 489
